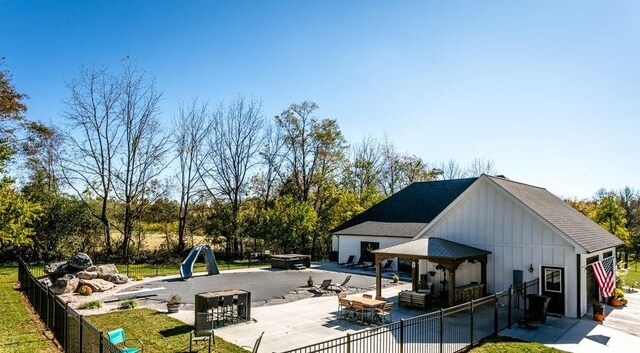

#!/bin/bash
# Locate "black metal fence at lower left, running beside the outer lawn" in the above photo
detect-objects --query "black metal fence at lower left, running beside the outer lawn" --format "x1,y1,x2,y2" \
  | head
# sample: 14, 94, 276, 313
18, 259, 119, 353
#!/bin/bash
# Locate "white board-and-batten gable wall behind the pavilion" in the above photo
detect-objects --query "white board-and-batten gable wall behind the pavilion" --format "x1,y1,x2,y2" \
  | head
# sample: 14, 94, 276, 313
420, 182, 578, 317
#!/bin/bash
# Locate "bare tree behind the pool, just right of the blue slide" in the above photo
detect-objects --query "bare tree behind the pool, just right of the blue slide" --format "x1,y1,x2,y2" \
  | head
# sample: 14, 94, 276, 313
203, 96, 263, 255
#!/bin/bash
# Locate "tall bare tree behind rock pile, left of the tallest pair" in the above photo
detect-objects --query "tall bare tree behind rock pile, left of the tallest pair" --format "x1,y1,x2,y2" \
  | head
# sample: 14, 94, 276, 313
59, 67, 122, 253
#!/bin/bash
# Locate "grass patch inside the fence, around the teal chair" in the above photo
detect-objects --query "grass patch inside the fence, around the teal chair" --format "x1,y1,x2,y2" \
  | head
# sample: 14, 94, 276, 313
85, 309, 249, 353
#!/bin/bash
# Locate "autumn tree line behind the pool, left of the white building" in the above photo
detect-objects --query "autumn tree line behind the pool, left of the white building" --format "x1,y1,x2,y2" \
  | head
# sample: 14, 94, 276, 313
0, 61, 497, 258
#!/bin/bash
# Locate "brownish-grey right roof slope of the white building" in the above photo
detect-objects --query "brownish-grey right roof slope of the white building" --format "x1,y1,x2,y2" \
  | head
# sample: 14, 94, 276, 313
488, 176, 624, 252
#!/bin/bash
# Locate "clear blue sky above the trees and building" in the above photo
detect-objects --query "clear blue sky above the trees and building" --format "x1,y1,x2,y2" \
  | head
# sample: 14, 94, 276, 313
0, 0, 640, 197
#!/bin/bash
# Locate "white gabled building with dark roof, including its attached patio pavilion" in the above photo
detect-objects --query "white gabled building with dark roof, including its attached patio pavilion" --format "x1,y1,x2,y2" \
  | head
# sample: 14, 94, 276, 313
334, 175, 623, 317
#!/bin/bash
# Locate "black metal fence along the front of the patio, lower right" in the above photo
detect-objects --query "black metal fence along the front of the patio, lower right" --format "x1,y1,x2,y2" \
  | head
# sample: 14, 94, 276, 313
283, 278, 538, 353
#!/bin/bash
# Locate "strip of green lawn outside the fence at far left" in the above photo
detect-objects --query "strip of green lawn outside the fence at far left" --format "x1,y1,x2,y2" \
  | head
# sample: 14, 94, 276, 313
0, 266, 60, 353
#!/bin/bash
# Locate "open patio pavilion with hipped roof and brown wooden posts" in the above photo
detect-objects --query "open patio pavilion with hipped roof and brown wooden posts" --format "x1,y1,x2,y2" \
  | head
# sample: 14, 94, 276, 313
372, 237, 491, 305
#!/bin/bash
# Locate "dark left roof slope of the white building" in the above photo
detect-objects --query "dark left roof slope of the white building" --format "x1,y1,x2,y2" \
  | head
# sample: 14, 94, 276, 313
333, 178, 478, 237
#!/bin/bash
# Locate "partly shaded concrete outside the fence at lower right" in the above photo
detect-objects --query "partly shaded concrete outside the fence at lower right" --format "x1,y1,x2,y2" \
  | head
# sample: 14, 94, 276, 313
500, 292, 640, 353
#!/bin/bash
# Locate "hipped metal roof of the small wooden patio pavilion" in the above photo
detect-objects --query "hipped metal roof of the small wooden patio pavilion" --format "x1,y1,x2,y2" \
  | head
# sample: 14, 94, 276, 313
373, 237, 491, 260
